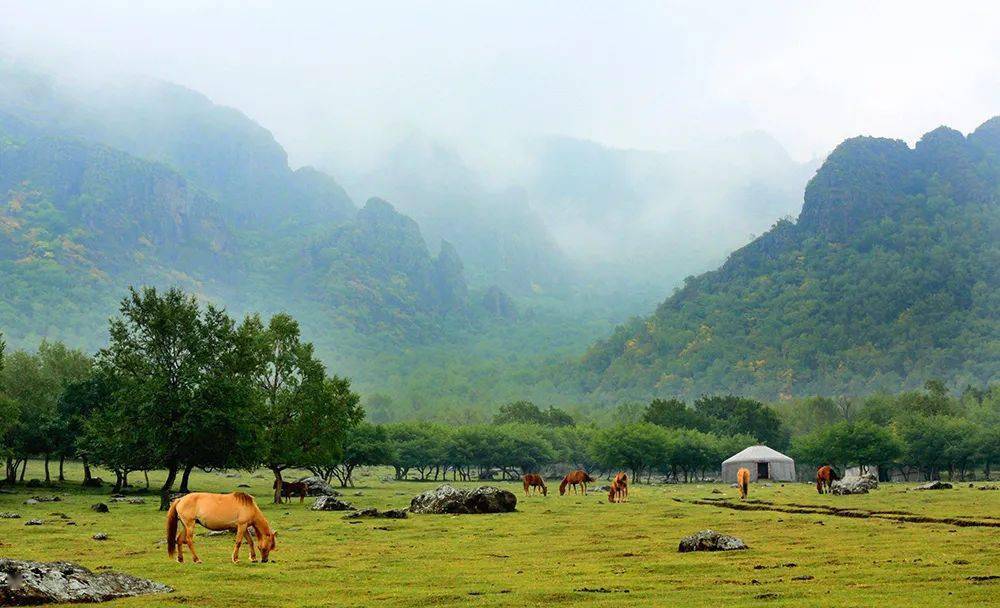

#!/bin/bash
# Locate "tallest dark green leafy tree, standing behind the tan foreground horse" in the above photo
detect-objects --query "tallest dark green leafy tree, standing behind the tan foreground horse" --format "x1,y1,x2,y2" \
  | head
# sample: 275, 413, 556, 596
98, 288, 257, 509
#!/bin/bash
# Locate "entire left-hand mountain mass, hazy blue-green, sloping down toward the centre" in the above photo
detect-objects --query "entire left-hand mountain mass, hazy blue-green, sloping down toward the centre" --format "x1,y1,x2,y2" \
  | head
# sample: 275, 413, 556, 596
0, 64, 488, 357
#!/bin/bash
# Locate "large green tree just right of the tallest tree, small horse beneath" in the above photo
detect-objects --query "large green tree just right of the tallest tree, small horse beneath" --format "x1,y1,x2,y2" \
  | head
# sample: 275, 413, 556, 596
244, 313, 364, 503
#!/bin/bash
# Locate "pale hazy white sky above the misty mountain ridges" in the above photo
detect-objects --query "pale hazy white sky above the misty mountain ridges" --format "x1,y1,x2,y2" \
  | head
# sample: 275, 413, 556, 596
0, 0, 1000, 163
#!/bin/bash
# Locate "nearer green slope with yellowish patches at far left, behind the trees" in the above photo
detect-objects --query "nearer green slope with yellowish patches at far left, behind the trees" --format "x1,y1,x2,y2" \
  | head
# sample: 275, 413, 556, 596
0, 114, 229, 344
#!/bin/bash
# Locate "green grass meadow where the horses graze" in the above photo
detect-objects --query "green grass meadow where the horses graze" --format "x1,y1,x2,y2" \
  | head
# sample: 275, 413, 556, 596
0, 463, 1000, 608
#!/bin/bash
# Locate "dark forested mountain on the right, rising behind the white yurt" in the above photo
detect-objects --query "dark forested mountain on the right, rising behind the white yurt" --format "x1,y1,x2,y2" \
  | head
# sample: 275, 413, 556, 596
582, 118, 1000, 397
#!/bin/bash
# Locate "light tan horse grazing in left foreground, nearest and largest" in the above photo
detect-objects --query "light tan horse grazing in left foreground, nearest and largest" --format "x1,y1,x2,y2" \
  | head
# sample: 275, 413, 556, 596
167, 492, 278, 564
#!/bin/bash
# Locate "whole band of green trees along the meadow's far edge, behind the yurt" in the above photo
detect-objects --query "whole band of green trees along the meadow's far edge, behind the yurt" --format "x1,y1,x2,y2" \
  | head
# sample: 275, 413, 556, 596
0, 288, 1000, 505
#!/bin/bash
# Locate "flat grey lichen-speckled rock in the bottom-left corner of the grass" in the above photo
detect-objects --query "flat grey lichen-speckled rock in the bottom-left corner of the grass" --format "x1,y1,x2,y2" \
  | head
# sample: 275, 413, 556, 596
0, 559, 173, 606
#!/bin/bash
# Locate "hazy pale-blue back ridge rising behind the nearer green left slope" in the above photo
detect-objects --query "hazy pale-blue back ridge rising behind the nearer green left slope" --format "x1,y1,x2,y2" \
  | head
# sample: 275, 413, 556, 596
0, 62, 355, 225
